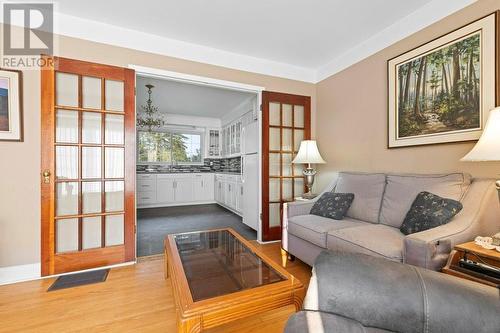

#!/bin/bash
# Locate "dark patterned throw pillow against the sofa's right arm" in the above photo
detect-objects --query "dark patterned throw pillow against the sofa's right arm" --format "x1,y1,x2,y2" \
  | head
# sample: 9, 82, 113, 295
399, 192, 463, 235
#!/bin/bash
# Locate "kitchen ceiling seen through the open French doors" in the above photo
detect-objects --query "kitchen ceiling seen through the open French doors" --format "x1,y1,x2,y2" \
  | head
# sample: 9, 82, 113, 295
136, 76, 255, 119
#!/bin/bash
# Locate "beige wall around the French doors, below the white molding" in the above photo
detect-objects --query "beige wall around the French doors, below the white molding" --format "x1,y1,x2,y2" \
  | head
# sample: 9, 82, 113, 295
0, 33, 316, 267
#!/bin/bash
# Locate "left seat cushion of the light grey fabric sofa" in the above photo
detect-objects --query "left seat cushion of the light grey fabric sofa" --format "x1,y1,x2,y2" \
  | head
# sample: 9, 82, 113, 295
288, 215, 370, 248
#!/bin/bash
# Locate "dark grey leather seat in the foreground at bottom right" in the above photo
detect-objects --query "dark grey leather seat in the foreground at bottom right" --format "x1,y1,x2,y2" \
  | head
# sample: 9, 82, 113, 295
285, 251, 500, 333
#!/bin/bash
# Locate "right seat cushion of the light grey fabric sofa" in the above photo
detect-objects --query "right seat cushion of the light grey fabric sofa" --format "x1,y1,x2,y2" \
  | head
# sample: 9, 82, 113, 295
327, 224, 404, 261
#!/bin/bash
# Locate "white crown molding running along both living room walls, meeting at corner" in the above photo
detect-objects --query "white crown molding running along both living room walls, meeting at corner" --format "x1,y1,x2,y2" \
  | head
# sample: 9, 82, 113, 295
0, 0, 478, 83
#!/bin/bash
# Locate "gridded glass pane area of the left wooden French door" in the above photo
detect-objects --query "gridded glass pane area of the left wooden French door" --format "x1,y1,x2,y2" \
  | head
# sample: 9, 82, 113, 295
54, 71, 125, 253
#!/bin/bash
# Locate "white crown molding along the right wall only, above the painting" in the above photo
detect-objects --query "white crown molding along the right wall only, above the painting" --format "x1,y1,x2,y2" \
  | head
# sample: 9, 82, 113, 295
316, 0, 477, 83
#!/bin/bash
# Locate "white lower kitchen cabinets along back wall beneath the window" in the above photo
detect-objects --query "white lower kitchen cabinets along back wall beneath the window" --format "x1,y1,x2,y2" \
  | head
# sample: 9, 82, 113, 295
137, 173, 214, 207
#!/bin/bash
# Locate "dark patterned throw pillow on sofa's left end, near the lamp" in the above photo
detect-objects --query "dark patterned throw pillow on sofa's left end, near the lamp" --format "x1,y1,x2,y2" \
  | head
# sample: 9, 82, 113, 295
311, 192, 354, 220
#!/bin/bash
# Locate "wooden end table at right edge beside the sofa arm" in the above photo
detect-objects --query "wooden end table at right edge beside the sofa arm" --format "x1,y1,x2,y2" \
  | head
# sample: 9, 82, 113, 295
442, 242, 500, 288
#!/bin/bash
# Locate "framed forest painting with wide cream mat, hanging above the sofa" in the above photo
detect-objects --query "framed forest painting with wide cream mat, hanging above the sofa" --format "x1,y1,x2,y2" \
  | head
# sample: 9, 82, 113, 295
388, 14, 496, 148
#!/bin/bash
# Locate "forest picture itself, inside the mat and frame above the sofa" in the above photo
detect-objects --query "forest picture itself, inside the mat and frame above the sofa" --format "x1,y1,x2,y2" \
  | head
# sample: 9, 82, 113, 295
396, 33, 481, 138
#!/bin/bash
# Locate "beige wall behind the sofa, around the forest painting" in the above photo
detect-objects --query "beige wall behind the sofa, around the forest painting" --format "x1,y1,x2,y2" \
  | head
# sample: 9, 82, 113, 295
316, 0, 500, 189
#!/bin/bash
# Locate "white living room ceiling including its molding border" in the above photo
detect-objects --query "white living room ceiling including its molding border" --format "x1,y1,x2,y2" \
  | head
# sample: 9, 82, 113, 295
4, 0, 476, 83
